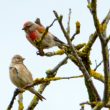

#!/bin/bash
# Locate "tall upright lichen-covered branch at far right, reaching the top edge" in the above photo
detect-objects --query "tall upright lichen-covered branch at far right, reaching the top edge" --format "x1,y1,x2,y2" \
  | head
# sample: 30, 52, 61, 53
91, 0, 110, 105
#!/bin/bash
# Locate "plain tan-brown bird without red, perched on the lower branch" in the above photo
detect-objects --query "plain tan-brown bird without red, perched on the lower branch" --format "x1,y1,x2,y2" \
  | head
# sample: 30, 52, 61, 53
9, 54, 45, 101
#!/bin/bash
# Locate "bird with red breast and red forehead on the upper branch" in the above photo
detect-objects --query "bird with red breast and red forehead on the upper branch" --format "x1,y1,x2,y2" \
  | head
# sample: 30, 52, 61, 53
22, 21, 66, 56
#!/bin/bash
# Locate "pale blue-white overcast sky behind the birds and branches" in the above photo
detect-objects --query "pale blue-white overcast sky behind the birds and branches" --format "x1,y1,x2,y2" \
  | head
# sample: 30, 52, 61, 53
0, 0, 110, 110
